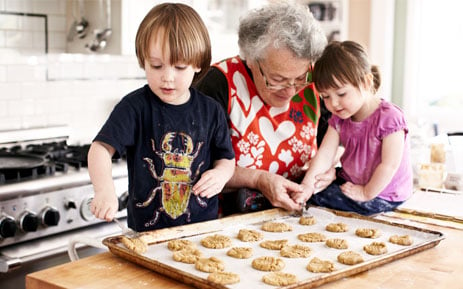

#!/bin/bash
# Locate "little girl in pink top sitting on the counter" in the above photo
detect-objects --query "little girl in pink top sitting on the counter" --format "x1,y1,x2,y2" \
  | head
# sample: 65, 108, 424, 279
293, 41, 413, 215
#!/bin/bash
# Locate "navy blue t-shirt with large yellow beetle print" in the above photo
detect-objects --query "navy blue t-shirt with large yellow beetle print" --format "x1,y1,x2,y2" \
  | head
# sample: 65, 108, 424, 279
94, 85, 234, 232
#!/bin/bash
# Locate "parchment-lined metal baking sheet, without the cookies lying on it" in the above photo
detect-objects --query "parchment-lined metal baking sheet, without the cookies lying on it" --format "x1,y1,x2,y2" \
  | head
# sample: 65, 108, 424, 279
103, 208, 444, 289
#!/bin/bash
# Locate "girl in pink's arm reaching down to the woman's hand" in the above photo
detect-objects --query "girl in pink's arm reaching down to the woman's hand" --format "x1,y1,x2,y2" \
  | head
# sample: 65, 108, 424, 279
292, 126, 339, 204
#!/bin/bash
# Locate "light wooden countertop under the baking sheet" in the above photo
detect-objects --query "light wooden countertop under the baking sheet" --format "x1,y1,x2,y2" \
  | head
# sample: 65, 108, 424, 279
26, 219, 463, 289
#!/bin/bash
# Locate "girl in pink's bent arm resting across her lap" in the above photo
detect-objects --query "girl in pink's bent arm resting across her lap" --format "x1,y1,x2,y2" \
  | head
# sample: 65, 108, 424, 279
341, 130, 405, 202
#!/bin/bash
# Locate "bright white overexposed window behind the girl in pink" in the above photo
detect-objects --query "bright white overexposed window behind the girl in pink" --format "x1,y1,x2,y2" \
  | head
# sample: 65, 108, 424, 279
400, 0, 463, 134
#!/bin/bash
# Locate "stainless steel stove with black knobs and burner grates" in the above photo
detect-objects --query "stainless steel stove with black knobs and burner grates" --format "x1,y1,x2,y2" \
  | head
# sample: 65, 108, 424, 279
0, 127, 128, 288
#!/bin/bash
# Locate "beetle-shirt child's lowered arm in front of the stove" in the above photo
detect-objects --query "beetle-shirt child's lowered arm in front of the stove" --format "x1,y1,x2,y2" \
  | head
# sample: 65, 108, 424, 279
88, 141, 119, 222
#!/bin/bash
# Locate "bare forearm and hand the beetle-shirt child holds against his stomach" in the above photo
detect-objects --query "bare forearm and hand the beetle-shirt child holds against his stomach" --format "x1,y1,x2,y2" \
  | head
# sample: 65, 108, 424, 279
193, 159, 235, 198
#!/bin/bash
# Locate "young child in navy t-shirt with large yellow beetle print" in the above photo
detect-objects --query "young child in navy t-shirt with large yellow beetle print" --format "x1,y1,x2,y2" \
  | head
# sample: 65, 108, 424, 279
88, 3, 235, 231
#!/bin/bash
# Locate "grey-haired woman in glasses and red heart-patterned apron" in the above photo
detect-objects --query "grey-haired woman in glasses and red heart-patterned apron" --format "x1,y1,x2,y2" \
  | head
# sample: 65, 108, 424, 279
197, 3, 334, 213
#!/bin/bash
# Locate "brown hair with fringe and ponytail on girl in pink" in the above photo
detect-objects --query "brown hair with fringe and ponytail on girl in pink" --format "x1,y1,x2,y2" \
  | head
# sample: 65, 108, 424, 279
312, 41, 381, 91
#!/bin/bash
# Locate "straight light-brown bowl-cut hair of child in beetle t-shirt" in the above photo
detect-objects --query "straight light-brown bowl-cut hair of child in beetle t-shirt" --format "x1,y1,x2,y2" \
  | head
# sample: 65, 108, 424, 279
135, 3, 211, 80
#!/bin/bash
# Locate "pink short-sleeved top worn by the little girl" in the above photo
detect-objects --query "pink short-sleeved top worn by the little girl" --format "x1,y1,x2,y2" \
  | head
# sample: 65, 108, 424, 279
328, 100, 413, 202
